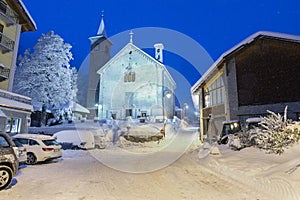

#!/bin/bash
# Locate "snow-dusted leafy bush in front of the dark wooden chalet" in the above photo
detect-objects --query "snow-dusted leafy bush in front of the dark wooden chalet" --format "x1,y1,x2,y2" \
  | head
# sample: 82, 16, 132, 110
247, 107, 300, 154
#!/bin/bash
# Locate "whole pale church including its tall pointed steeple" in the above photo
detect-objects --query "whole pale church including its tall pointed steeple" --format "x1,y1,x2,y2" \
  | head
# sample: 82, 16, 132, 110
87, 15, 176, 119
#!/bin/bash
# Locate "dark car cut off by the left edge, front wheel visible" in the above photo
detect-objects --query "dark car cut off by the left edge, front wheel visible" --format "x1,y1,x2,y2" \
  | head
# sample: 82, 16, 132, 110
0, 133, 19, 190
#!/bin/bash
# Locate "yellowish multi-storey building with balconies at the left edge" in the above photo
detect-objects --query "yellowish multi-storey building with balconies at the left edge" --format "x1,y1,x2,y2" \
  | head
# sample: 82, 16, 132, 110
0, 0, 36, 134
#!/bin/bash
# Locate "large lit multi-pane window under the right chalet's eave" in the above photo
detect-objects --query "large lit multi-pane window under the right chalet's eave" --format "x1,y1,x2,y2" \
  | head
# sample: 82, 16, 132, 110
204, 77, 225, 107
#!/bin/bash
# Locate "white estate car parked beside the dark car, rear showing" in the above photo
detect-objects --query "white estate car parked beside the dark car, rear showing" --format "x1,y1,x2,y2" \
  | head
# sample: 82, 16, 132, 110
13, 134, 62, 165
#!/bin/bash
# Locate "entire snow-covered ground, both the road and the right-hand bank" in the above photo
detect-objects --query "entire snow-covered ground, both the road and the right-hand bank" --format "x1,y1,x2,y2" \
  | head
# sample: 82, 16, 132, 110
0, 123, 300, 200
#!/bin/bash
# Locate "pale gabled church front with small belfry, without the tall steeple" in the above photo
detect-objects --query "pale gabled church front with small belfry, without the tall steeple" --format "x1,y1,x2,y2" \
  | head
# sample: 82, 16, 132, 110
97, 39, 176, 119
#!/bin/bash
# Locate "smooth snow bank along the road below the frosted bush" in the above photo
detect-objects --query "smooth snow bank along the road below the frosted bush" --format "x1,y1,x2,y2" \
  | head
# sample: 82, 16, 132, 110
193, 141, 300, 200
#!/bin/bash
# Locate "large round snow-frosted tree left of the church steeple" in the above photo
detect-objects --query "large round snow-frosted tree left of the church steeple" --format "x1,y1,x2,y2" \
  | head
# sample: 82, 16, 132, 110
14, 31, 77, 116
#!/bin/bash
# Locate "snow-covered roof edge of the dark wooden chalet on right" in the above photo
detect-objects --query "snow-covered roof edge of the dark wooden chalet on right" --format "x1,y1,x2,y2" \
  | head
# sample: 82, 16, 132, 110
191, 31, 300, 94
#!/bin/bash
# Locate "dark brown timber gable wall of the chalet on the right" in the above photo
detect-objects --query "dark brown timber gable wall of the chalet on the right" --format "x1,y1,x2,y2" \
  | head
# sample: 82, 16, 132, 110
232, 38, 300, 120
